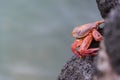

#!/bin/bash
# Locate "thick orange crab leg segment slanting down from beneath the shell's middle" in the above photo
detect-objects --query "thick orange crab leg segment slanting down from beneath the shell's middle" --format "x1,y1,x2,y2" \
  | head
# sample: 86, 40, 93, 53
78, 33, 93, 54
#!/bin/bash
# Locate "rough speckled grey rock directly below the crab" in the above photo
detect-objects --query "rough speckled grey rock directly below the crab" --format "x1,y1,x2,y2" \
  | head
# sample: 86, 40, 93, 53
58, 56, 96, 80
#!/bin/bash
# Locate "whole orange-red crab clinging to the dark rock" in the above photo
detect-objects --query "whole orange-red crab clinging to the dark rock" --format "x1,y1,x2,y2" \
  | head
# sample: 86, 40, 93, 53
71, 20, 104, 57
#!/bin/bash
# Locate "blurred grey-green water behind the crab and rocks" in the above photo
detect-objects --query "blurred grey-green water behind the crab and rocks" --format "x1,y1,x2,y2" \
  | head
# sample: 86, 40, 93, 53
0, 0, 101, 80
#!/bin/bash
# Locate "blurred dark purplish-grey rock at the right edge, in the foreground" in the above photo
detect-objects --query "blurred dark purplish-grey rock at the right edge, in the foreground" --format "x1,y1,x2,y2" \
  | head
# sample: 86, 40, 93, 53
104, 6, 120, 74
